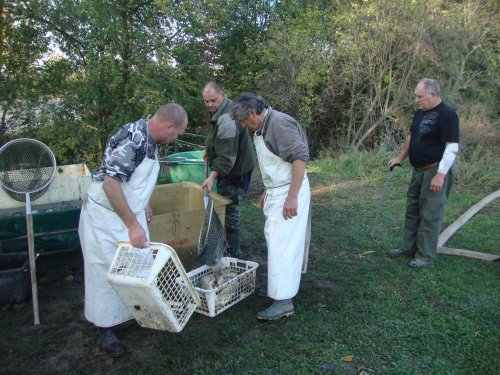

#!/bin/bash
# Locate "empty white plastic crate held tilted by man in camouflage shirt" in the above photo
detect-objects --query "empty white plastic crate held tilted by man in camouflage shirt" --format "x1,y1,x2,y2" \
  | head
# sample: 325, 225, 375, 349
108, 241, 201, 332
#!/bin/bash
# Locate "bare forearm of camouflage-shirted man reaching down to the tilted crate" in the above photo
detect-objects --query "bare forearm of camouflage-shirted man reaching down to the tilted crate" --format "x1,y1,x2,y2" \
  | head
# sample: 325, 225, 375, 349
102, 176, 148, 248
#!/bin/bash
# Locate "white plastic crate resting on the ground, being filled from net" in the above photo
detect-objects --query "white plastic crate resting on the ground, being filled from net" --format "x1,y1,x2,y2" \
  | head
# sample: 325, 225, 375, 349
187, 257, 259, 317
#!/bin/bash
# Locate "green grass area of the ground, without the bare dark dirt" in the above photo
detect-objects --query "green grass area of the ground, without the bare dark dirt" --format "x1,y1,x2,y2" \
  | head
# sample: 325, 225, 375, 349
144, 151, 500, 374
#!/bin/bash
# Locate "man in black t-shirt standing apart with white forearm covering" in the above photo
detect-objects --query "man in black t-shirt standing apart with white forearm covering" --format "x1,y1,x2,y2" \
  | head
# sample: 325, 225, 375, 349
388, 78, 459, 268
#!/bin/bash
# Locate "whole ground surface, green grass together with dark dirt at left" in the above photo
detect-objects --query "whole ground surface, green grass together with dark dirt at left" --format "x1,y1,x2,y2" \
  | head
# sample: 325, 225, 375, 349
0, 151, 500, 375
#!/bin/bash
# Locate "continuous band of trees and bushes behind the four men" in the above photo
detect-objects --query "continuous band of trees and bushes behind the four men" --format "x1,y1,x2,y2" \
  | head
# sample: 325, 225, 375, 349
0, 0, 500, 167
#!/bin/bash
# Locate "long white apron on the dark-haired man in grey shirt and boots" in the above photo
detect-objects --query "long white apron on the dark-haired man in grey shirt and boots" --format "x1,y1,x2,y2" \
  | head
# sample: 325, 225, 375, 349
254, 135, 311, 300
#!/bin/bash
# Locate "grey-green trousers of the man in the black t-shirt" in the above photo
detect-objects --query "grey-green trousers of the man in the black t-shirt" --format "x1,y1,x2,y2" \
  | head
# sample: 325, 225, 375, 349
401, 165, 456, 260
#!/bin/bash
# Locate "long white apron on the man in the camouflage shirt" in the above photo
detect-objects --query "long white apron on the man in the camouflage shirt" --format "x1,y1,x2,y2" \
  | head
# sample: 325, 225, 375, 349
78, 157, 160, 327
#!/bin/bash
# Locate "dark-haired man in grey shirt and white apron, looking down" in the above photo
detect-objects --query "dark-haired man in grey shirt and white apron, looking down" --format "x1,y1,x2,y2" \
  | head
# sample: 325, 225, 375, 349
231, 93, 311, 320
